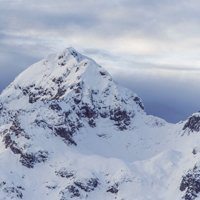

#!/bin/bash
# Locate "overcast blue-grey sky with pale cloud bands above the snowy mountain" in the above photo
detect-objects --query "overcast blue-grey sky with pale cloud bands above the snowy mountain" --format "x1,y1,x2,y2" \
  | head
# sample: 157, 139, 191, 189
0, 0, 200, 122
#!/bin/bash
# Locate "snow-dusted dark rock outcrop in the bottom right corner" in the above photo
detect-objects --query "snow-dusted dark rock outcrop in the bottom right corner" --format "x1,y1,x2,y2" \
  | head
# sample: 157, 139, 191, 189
180, 166, 200, 200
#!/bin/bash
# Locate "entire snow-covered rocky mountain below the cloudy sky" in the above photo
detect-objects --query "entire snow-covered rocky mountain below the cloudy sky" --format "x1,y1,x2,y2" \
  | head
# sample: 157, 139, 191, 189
0, 48, 200, 200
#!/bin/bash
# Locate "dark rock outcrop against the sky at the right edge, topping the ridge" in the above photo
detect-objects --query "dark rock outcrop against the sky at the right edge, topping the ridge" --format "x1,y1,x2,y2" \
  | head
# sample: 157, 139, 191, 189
183, 115, 200, 132
